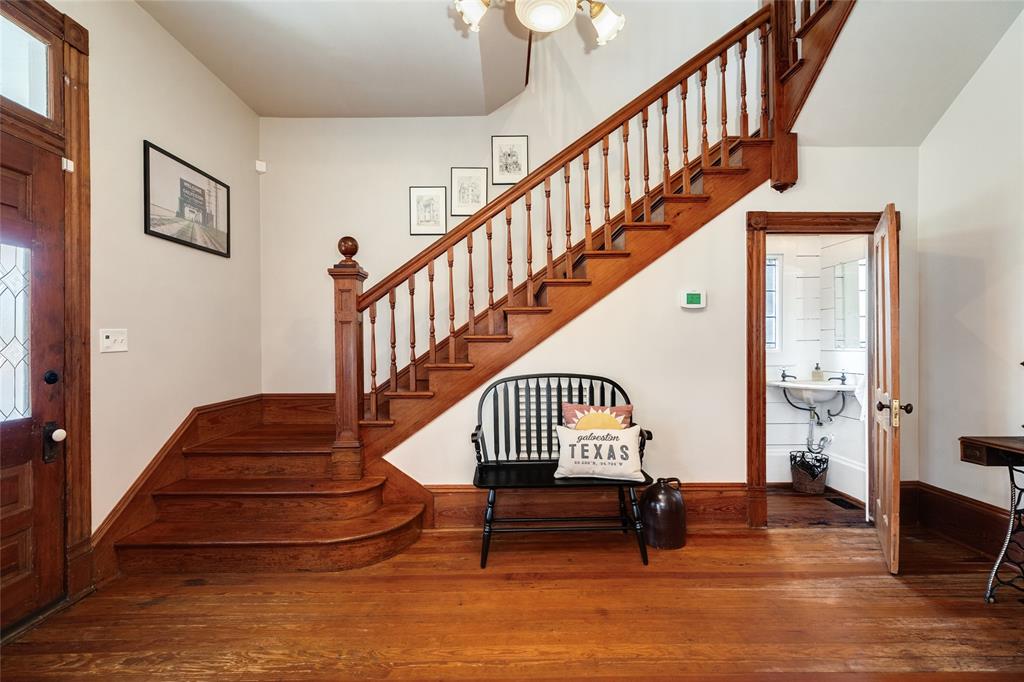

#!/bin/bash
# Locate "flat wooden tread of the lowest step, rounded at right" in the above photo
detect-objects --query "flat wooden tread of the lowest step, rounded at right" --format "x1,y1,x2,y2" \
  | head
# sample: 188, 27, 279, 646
117, 504, 423, 548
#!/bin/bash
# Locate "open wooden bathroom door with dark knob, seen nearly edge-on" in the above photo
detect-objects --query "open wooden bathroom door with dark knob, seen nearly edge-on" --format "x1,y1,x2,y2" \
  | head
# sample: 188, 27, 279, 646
867, 204, 913, 573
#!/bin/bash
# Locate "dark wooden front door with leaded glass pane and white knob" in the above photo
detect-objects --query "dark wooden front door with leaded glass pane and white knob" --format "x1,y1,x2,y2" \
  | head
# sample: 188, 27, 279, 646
0, 132, 65, 628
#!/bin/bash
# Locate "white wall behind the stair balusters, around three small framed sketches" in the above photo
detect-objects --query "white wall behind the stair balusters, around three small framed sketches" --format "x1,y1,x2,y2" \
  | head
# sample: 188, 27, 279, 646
260, 0, 759, 392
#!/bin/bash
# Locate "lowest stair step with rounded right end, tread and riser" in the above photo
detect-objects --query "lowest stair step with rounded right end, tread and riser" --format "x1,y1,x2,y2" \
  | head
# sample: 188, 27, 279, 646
117, 504, 423, 573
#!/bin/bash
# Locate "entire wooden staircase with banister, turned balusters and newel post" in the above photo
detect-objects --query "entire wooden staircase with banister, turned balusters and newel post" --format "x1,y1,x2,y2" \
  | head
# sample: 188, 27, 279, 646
116, 0, 853, 572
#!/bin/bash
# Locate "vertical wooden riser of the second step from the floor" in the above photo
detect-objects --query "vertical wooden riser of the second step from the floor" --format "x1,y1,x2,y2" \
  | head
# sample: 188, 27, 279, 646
154, 487, 382, 522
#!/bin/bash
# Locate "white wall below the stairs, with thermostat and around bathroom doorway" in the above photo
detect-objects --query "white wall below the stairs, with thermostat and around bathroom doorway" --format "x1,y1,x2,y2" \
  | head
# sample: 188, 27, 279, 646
388, 147, 918, 483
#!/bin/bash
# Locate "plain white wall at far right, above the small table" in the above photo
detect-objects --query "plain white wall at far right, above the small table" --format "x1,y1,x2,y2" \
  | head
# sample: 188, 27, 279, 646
917, 15, 1024, 506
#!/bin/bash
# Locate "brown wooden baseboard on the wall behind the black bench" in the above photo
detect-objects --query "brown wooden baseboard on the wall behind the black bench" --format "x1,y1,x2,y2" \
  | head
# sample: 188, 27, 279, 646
426, 483, 746, 528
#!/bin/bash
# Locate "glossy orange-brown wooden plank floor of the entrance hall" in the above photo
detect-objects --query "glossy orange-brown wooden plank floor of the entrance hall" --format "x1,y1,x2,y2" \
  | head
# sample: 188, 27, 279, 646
0, 520, 1024, 682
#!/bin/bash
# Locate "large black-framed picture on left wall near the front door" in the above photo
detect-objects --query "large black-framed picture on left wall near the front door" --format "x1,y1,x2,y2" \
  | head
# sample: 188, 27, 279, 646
142, 140, 231, 258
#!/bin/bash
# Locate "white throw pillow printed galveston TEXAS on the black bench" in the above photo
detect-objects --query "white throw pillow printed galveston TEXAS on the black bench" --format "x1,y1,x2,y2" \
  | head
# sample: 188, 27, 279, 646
555, 426, 644, 481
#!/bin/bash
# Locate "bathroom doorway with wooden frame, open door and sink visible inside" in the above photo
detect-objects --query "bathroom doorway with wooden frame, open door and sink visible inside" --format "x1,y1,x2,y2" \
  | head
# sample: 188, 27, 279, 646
748, 205, 912, 572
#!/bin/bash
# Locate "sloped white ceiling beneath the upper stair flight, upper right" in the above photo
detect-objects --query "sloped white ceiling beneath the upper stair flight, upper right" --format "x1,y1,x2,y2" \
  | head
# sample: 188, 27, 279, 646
796, 0, 1024, 146
